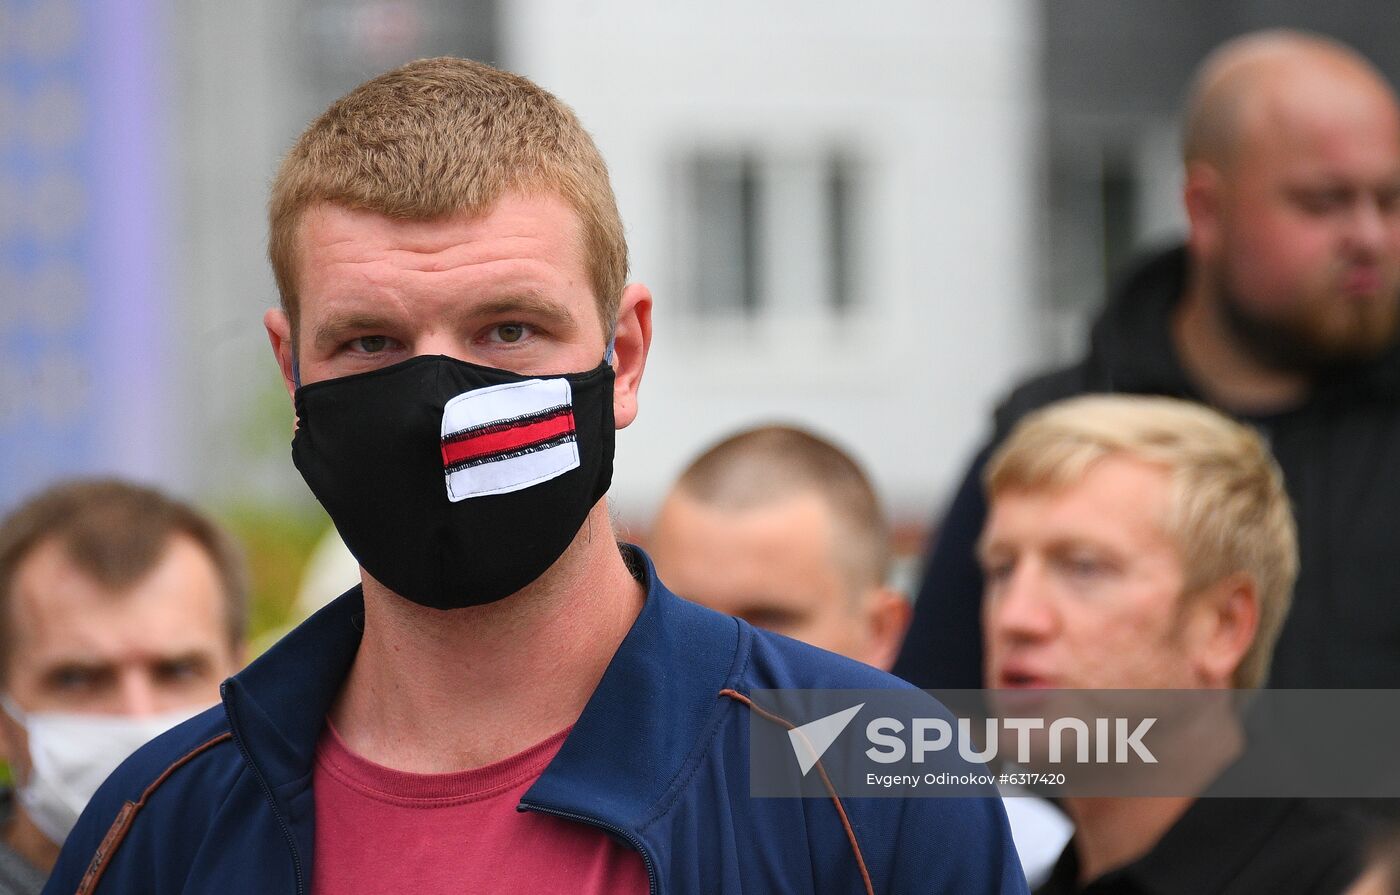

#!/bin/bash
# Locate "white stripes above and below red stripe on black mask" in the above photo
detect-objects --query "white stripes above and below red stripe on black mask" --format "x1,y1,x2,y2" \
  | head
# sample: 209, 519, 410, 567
442, 380, 578, 503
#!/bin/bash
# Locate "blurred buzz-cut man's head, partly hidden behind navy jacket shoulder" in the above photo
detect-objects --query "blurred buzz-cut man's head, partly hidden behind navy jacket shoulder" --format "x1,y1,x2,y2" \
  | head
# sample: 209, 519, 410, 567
650, 426, 910, 671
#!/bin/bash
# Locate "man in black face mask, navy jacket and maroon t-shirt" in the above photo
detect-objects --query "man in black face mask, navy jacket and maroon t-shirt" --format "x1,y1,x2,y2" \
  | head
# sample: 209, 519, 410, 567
48, 59, 1025, 895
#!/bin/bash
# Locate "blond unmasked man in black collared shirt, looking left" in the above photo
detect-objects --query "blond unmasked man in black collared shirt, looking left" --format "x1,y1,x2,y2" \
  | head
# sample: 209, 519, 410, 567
977, 395, 1364, 895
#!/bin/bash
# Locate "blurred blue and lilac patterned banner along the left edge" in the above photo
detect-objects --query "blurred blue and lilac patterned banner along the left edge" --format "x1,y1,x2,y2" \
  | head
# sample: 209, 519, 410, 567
0, 0, 174, 511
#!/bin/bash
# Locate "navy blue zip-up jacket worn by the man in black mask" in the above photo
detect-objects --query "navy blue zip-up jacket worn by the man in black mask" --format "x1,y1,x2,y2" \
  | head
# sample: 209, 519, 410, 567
43, 550, 1026, 895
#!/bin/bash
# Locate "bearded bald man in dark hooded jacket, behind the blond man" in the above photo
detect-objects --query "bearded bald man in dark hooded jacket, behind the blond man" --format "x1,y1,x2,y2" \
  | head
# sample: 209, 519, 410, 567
895, 31, 1400, 688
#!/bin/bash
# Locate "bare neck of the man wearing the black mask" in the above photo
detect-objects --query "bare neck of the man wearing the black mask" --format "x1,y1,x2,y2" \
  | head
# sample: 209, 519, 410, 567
330, 501, 645, 773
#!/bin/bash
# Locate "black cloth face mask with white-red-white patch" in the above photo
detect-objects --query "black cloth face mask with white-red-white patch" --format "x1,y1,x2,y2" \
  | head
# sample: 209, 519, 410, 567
291, 356, 615, 609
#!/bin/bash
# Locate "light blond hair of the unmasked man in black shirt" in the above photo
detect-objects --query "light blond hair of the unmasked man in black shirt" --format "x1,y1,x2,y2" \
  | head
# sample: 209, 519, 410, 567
983, 395, 1298, 688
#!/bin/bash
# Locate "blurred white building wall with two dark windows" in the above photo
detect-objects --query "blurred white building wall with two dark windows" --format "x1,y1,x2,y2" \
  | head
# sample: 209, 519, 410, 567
503, 0, 1037, 521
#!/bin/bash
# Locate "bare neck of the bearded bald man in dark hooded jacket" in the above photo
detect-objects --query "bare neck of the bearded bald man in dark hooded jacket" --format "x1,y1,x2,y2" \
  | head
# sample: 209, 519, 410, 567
1172, 263, 1309, 416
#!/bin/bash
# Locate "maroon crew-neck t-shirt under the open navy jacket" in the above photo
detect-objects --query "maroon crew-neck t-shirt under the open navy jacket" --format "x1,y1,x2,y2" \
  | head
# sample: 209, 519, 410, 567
311, 723, 648, 895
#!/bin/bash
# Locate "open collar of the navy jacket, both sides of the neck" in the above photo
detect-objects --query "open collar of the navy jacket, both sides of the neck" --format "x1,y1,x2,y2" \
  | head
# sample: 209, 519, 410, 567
224, 546, 749, 829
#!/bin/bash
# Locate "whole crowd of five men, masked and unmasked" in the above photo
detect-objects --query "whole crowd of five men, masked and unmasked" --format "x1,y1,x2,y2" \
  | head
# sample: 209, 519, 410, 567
0, 24, 1400, 895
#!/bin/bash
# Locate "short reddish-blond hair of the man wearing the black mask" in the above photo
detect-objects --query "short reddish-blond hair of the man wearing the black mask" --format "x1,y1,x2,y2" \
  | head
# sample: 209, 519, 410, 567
267, 56, 627, 341
